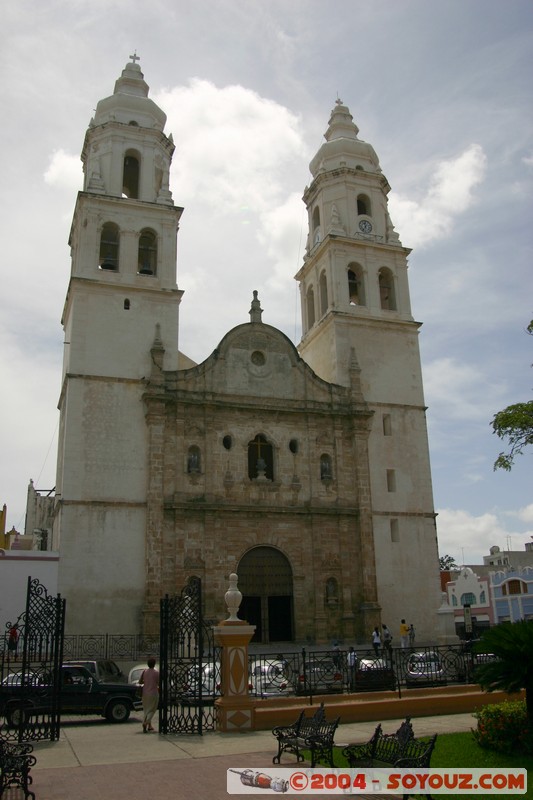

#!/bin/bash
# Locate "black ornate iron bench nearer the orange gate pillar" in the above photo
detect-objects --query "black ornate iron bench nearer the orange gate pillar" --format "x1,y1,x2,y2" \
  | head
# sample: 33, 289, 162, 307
272, 703, 340, 767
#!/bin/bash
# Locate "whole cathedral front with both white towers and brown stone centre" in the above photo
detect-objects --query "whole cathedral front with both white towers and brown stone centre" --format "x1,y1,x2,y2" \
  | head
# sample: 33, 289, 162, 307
53, 59, 440, 643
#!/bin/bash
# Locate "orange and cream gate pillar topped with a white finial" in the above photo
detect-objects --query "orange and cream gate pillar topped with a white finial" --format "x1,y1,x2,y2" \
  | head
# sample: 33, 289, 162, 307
213, 573, 255, 733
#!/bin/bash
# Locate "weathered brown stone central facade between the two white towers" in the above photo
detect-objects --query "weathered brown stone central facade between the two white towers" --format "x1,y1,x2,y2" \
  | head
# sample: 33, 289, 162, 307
144, 322, 378, 641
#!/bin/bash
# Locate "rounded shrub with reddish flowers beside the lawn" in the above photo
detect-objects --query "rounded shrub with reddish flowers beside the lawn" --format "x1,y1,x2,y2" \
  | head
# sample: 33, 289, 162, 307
473, 700, 533, 754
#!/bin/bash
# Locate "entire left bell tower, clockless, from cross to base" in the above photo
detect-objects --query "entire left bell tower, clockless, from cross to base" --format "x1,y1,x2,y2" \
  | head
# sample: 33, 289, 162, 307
54, 55, 182, 632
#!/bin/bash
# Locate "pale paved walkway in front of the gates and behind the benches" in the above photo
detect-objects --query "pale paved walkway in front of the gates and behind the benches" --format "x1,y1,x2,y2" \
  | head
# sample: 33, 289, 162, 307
31, 714, 476, 800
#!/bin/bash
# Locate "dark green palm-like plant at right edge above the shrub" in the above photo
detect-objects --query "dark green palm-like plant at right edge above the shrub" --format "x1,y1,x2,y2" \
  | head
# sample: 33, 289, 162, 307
473, 619, 533, 724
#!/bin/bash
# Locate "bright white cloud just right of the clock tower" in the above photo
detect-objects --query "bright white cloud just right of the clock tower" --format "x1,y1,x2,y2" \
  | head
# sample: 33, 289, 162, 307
389, 144, 487, 248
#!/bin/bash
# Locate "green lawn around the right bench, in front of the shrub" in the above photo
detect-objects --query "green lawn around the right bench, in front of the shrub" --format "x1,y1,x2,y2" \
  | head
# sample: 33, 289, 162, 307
305, 732, 533, 800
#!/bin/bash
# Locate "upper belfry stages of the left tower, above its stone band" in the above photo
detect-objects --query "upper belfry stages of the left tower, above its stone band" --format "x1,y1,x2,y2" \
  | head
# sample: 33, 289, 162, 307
62, 56, 183, 378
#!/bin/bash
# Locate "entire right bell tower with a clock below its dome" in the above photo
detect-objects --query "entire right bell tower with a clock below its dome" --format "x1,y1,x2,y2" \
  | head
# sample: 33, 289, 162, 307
296, 100, 440, 627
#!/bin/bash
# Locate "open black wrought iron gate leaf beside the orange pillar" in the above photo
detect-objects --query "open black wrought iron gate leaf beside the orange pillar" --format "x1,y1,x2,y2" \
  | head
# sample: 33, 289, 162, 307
159, 577, 220, 735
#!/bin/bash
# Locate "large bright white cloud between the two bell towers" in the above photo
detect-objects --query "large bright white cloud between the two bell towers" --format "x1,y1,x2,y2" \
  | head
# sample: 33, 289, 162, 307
154, 78, 304, 214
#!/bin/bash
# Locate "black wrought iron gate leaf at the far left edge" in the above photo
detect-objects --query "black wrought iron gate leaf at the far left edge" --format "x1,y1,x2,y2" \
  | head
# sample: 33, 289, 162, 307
0, 577, 66, 741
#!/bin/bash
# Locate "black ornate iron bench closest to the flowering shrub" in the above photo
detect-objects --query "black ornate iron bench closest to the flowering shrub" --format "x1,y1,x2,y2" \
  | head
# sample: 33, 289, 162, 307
342, 717, 437, 800
